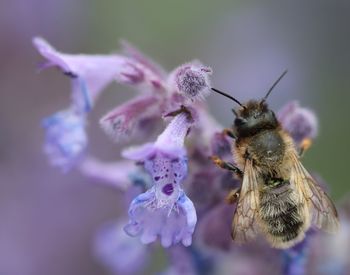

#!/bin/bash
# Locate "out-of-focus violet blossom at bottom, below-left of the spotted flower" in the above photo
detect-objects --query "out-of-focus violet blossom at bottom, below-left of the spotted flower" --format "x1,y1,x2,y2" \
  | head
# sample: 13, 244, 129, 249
94, 221, 150, 274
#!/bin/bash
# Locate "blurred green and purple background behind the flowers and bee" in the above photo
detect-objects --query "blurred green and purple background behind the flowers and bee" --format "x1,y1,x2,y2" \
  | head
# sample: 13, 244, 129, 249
0, 0, 350, 275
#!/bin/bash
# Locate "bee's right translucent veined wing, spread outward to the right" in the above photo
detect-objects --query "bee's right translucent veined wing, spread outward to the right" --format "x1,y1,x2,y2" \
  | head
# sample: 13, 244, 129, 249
291, 154, 339, 233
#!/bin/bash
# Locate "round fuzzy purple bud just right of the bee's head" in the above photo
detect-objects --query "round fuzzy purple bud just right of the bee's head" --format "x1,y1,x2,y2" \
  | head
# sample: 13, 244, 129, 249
278, 101, 318, 144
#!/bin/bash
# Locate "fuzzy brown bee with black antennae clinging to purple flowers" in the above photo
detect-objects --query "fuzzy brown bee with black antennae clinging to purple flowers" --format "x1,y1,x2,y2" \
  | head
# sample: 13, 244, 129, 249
212, 71, 339, 249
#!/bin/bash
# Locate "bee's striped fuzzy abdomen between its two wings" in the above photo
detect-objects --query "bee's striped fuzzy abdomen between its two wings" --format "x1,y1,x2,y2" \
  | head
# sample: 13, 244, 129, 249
259, 182, 304, 246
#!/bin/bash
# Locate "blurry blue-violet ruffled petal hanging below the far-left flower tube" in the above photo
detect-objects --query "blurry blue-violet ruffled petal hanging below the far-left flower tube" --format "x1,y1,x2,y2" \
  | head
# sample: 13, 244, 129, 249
42, 109, 87, 171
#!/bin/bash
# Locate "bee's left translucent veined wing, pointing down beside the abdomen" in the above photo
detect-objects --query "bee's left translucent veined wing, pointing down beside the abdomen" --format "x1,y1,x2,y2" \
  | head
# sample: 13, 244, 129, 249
232, 160, 259, 243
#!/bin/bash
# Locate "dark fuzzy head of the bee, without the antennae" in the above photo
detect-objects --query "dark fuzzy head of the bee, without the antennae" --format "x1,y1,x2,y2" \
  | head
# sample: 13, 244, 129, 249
233, 100, 278, 137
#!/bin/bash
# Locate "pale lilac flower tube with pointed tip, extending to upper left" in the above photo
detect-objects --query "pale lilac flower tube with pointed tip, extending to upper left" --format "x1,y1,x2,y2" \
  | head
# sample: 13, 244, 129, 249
33, 37, 163, 105
